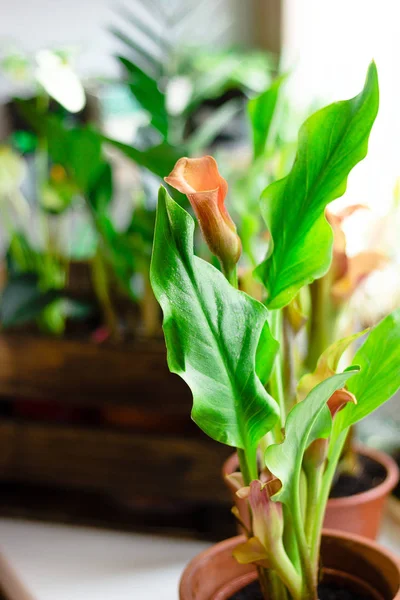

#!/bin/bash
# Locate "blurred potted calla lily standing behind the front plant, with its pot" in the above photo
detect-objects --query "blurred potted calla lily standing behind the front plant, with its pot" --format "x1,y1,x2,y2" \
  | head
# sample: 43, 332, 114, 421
216, 78, 398, 539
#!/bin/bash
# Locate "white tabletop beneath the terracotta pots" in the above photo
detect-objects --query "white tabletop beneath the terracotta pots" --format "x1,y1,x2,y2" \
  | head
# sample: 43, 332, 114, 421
0, 519, 400, 600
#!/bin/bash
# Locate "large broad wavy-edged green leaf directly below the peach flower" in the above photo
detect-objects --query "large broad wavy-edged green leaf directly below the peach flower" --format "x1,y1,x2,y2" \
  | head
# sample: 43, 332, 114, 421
150, 187, 278, 449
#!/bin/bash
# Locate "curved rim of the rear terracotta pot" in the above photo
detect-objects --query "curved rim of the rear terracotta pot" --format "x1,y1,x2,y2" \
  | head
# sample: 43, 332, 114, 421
222, 443, 400, 508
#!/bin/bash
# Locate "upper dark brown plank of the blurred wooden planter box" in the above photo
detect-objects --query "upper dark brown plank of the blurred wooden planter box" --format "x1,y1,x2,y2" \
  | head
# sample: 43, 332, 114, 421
0, 334, 192, 415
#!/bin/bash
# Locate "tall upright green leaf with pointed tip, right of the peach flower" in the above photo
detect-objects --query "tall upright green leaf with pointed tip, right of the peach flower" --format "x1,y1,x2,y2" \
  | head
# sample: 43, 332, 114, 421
256, 63, 379, 309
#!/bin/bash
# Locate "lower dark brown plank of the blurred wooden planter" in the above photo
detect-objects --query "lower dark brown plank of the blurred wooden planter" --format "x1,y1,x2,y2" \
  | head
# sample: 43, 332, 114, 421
0, 421, 231, 504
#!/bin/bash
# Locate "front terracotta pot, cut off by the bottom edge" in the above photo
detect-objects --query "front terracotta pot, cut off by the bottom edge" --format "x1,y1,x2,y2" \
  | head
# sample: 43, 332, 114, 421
179, 530, 400, 600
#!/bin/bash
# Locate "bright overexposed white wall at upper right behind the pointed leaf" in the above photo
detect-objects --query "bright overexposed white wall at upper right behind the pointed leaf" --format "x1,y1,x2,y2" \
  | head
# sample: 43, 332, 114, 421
284, 0, 400, 212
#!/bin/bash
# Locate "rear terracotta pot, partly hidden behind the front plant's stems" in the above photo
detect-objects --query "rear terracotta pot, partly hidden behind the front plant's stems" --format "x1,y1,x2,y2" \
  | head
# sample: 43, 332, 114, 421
222, 445, 399, 540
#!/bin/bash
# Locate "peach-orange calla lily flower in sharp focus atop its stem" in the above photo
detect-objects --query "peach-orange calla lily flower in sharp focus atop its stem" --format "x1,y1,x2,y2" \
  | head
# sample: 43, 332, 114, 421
165, 156, 242, 274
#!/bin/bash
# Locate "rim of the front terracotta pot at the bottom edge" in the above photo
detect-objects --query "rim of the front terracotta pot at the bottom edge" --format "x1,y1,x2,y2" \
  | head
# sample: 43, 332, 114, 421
179, 529, 400, 598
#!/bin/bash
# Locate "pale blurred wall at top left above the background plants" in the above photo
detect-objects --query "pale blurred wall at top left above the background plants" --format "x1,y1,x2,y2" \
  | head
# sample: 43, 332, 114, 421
0, 0, 250, 95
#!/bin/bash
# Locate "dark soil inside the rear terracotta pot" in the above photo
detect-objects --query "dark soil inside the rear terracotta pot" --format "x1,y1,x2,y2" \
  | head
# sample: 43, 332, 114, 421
329, 455, 387, 498
